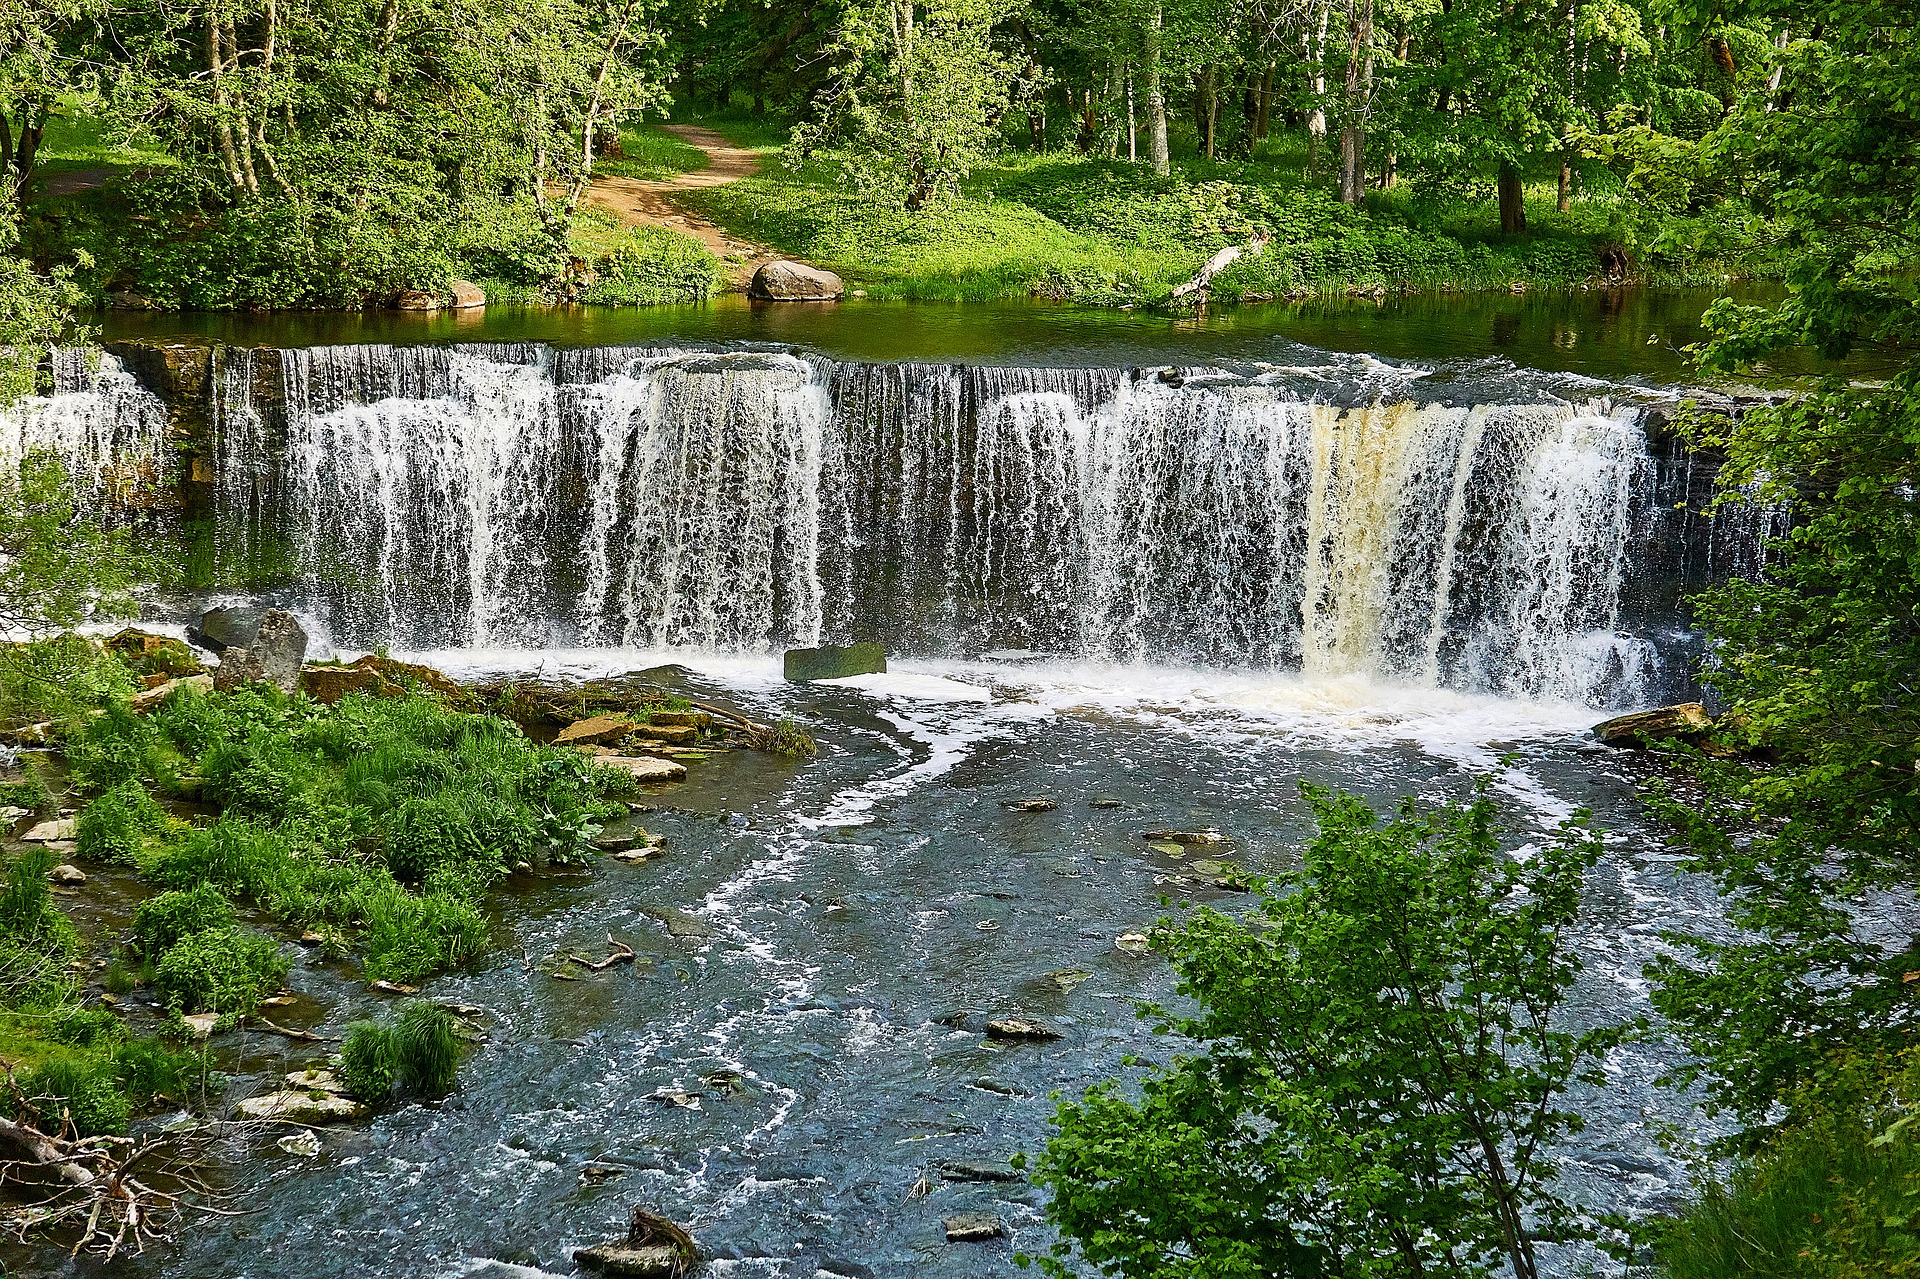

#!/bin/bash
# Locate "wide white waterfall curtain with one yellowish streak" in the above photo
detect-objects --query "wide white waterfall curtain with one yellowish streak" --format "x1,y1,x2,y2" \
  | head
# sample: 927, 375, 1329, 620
236, 337, 1657, 703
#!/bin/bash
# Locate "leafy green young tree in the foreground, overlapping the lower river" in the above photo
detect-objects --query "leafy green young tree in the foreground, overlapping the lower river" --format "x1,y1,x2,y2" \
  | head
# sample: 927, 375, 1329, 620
1037, 787, 1626, 1279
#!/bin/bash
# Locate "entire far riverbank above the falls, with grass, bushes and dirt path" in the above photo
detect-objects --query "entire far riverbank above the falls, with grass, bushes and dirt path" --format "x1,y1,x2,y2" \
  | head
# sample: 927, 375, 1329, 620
25, 105, 1784, 320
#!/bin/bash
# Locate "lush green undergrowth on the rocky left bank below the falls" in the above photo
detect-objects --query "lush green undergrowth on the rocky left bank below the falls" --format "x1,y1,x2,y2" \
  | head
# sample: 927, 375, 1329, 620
0, 636, 626, 1135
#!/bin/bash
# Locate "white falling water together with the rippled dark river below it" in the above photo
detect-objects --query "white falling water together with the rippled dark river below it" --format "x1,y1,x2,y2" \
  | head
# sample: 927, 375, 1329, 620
0, 300, 1766, 1279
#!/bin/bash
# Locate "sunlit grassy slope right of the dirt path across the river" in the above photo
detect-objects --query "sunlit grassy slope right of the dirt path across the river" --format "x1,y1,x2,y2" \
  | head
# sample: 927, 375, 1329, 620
689, 121, 1740, 305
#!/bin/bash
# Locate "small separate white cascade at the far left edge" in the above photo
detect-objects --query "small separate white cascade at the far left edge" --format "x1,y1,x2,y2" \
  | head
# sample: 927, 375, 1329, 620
0, 348, 175, 511
